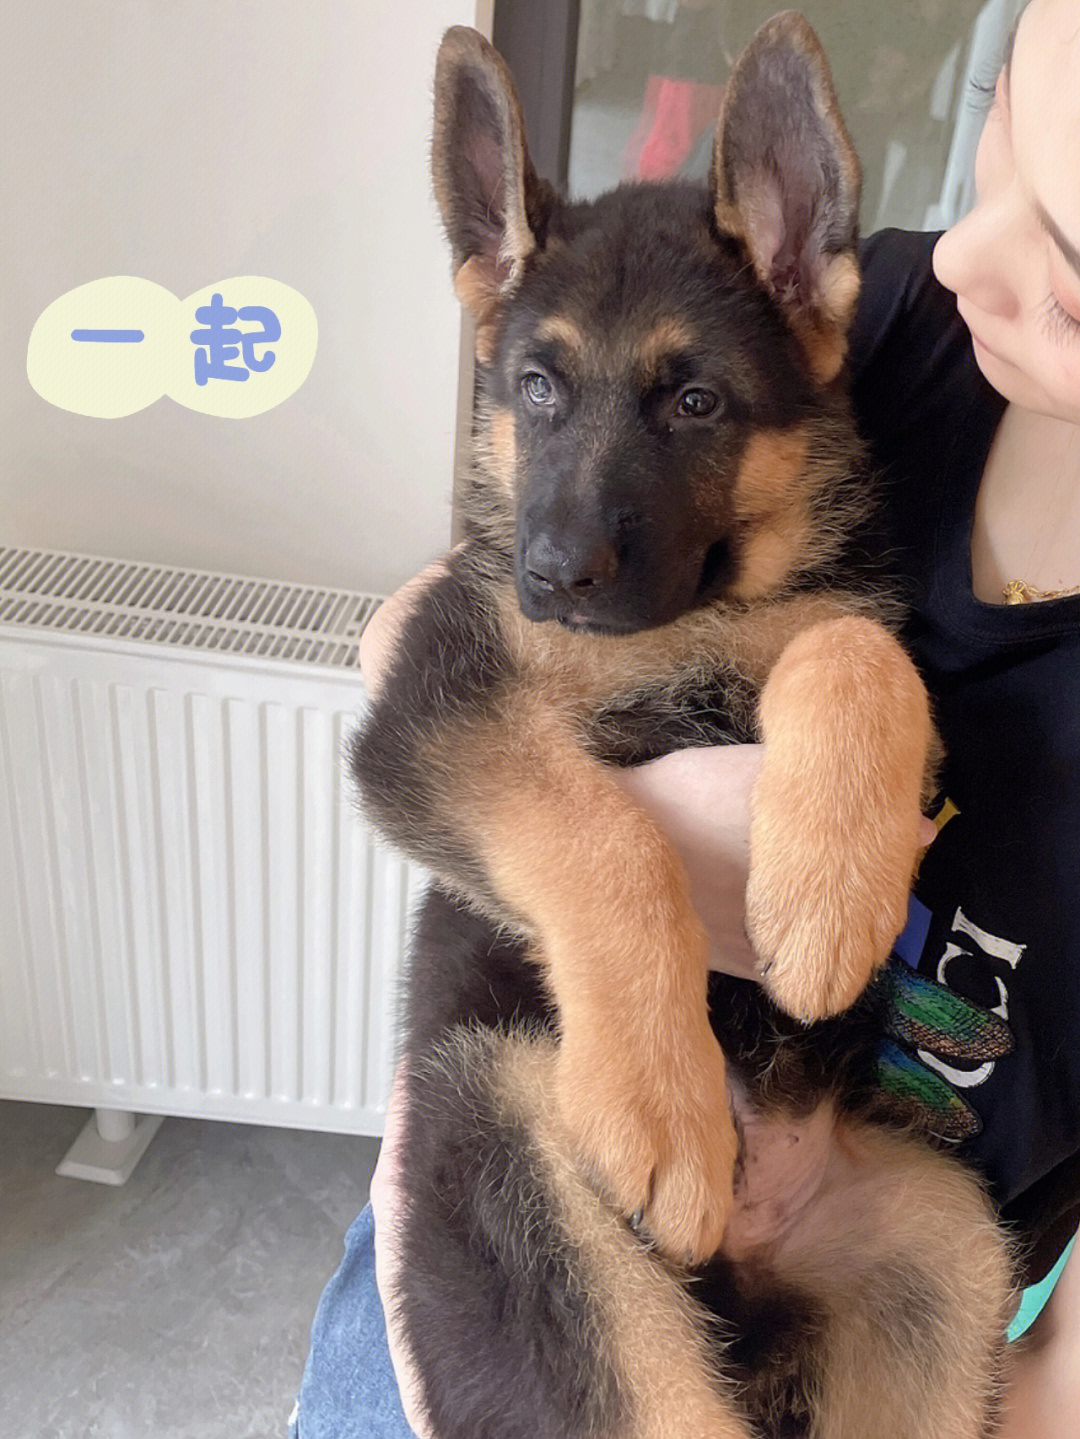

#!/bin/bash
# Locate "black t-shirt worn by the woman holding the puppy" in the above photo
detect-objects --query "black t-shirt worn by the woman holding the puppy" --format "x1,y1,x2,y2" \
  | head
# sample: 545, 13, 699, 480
851, 230, 1080, 1278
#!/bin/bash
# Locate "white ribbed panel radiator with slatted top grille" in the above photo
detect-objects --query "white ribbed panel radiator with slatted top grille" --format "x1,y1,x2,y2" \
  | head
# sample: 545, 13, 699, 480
0, 548, 423, 1134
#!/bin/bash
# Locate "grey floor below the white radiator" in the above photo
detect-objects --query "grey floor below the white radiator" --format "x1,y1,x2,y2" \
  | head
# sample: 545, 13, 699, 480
0, 1102, 377, 1439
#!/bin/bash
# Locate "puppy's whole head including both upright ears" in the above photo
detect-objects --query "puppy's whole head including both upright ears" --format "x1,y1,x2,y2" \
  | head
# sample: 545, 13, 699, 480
433, 16, 859, 633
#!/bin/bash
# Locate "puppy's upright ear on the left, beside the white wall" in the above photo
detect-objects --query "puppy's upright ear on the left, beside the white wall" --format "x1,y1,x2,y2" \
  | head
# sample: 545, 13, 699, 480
431, 26, 555, 360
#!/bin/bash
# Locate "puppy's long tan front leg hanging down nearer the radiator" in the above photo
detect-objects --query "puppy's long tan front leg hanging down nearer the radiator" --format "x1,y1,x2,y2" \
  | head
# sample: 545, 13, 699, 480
467, 701, 736, 1262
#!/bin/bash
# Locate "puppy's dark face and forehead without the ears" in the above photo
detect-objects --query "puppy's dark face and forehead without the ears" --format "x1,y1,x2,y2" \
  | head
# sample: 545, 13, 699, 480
488, 186, 821, 633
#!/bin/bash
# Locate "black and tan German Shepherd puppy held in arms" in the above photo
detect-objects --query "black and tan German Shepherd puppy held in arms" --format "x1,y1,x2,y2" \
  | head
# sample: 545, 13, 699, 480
351, 13, 1010, 1439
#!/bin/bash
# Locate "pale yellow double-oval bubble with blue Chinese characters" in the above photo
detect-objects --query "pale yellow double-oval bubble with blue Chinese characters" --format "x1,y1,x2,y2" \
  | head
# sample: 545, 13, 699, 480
26, 275, 318, 419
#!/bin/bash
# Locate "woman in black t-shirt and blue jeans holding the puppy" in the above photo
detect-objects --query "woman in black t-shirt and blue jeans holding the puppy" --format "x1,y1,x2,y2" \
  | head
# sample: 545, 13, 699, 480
295, 0, 1080, 1439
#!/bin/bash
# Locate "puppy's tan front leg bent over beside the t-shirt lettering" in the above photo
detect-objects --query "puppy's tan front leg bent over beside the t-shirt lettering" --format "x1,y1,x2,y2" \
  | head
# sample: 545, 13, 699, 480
746, 616, 933, 1020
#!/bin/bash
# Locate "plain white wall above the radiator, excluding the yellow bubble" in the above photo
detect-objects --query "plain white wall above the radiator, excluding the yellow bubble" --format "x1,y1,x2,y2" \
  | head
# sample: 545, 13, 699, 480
0, 0, 490, 591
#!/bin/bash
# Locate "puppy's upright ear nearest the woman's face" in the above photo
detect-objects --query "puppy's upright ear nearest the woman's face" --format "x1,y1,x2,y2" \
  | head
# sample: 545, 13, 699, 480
709, 10, 861, 383
